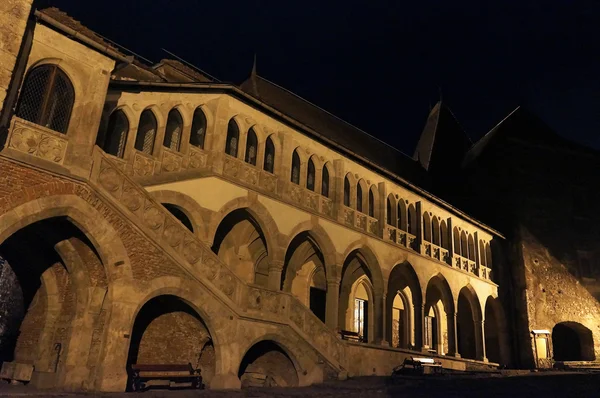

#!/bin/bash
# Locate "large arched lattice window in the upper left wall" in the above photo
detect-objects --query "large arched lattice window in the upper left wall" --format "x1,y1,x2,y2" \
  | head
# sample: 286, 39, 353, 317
16, 65, 75, 134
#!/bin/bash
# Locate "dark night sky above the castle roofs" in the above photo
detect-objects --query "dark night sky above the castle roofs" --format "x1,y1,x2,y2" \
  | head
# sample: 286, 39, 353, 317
49, 0, 600, 155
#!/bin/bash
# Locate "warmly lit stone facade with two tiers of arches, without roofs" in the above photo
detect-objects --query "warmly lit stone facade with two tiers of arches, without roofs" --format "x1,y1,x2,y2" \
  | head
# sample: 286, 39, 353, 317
0, 1, 598, 391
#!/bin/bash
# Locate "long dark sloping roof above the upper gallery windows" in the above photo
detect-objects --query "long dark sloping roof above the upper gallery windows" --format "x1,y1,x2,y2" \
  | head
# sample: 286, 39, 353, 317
240, 71, 428, 186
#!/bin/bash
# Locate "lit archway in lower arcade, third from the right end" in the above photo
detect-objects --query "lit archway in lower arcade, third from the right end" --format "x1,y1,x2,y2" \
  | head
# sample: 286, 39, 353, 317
422, 274, 456, 355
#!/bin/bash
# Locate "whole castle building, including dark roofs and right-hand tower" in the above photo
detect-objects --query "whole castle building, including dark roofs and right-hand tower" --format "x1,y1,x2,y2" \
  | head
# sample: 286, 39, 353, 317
0, 0, 600, 391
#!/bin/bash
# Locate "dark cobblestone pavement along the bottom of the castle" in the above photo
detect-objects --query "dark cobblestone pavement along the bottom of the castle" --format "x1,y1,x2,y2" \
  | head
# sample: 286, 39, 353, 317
0, 372, 600, 398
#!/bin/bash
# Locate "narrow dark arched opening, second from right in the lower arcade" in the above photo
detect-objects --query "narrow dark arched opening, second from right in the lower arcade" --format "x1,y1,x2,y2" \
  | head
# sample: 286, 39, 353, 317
456, 287, 483, 359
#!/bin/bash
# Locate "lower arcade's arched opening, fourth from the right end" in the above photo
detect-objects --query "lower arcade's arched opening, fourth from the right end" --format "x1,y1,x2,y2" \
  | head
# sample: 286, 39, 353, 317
386, 262, 422, 349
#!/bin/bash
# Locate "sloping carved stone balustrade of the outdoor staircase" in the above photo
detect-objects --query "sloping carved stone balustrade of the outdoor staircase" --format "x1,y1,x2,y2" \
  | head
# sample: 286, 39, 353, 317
90, 147, 346, 372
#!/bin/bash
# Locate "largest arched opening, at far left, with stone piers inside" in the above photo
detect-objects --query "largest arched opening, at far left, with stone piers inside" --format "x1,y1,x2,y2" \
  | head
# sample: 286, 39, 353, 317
0, 217, 108, 385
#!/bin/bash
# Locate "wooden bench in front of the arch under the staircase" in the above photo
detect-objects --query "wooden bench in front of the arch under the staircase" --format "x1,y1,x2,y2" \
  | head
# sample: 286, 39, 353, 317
130, 363, 203, 391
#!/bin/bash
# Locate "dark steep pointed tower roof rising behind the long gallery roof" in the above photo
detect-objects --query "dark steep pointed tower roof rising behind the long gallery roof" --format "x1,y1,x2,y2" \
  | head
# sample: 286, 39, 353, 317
413, 101, 471, 171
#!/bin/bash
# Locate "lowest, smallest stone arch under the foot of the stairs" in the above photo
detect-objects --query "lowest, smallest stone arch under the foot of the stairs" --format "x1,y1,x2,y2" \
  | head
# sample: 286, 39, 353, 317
237, 334, 303, 388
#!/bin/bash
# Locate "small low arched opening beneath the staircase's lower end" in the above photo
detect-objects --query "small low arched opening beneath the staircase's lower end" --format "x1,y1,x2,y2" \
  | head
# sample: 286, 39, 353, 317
238, 340, 298, 388
